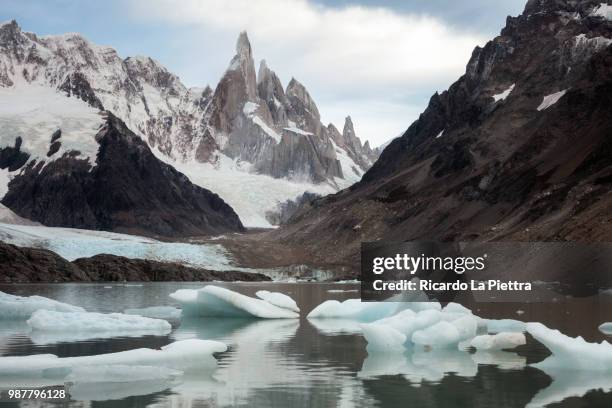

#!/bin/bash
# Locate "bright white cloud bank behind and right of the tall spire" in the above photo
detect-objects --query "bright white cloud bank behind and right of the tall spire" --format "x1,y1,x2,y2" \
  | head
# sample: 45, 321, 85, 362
125, 0, 485, 145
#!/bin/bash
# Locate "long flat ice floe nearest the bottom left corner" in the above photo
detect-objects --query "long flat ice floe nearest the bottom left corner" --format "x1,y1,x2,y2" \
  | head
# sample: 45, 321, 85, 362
0, 339, 227, 378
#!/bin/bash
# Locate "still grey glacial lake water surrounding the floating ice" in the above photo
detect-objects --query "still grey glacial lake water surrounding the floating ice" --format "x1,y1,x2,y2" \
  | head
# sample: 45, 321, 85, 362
0, 282, 612, 408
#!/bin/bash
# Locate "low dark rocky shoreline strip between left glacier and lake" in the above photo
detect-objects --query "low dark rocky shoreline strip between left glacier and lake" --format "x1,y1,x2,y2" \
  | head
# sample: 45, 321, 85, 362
0, 242, 271, 283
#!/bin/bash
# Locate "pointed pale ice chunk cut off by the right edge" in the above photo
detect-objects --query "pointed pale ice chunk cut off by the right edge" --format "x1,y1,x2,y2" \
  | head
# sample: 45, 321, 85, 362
527, 323, 612, 371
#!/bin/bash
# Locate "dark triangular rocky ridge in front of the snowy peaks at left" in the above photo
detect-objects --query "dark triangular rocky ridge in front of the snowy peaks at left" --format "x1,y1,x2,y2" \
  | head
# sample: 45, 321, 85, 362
0, 114, 244, 237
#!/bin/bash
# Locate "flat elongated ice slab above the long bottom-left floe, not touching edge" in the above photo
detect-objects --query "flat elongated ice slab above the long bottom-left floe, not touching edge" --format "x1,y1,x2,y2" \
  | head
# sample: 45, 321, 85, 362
27, 310, 172, 334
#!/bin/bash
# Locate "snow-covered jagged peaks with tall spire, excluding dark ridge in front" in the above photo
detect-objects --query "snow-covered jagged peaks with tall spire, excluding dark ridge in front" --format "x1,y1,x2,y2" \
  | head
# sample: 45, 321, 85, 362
0, 21, 377, 226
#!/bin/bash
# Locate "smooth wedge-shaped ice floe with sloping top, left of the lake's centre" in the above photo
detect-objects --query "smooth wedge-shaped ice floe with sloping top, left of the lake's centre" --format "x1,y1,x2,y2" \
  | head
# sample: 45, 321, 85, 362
170, 285, 299, 319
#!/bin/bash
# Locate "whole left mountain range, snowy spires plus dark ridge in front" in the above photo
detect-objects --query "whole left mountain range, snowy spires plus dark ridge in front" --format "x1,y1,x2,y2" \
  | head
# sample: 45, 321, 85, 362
0, 21, 379, 236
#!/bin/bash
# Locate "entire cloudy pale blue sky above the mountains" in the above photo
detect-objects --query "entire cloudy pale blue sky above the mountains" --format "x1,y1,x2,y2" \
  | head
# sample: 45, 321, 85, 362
0, 0, 525, 146
